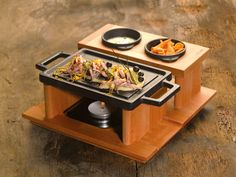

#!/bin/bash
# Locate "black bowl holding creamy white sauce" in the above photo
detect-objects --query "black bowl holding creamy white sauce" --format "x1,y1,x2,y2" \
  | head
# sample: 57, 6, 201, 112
102, 28, 141, 50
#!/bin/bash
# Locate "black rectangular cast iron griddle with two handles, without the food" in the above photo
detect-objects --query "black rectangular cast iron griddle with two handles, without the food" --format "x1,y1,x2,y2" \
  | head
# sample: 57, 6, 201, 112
36, 48, 180, 110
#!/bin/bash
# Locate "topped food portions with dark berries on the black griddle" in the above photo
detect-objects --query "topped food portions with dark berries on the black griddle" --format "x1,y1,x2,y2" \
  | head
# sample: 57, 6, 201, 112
53, 55, 144, 91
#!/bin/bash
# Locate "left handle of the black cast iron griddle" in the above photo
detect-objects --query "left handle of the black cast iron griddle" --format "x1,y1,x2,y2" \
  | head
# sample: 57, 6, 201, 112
35, 51, 70, 71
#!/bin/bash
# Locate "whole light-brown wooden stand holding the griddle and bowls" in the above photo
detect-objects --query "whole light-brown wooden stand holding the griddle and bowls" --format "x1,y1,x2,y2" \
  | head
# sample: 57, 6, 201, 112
23, 24, 216, 162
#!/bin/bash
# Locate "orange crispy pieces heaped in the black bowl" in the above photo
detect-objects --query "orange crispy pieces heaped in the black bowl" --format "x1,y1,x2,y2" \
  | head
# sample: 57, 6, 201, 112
151, 39, 184, 55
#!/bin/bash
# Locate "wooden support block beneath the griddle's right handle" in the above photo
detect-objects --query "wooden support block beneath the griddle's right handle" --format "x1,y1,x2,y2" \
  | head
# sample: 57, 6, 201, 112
122, 88, 167, 145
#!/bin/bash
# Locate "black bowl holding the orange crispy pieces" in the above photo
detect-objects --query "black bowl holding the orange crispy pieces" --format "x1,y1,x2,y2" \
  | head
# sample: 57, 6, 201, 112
145, 38, 186, 62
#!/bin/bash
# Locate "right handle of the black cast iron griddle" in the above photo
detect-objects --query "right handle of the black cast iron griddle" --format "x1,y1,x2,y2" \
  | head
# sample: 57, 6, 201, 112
142, 80, 180, 106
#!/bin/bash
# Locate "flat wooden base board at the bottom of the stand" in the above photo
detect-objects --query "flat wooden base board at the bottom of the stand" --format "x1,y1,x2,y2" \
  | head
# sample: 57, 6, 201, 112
23, 87, 216, 163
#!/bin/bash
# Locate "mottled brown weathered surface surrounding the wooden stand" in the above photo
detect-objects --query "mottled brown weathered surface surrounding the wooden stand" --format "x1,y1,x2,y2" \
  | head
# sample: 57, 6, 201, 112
0, 0, 236, 177
